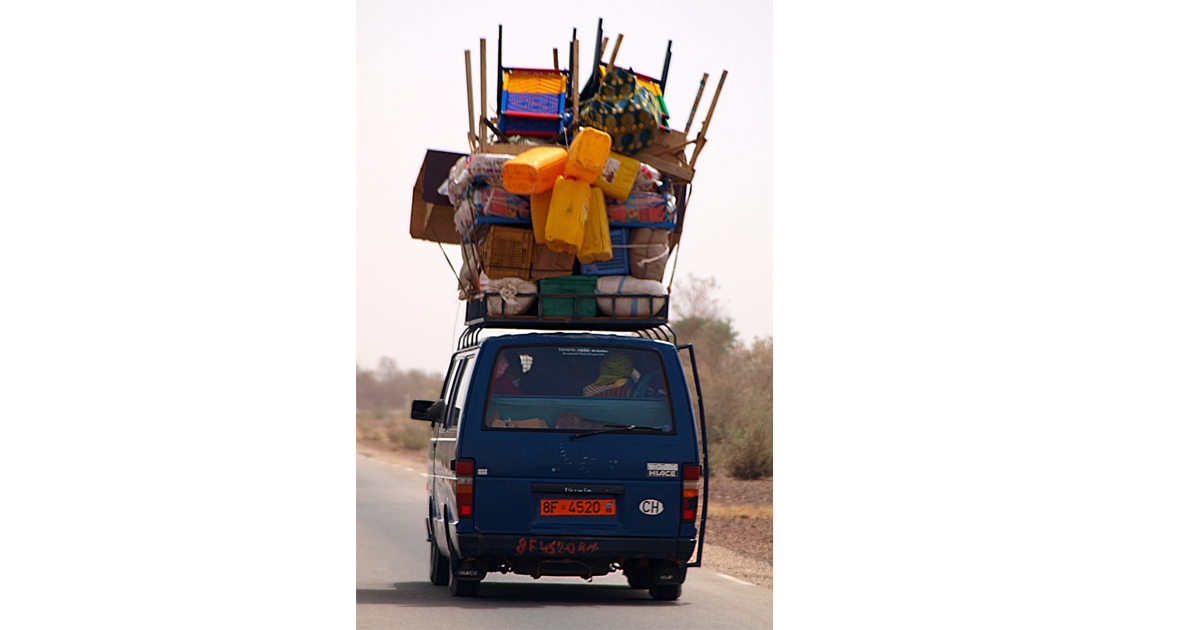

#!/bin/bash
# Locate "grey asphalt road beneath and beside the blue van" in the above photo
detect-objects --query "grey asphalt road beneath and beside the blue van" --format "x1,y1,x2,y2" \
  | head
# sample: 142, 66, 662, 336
356, 455, 772, 630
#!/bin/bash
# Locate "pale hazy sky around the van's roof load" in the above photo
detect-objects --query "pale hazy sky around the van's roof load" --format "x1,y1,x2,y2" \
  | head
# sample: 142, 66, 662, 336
356, 0, 774, 372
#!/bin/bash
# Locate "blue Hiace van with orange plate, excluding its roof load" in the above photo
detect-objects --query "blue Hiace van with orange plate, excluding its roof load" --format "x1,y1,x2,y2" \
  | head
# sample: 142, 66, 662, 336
412, 332, 708, 600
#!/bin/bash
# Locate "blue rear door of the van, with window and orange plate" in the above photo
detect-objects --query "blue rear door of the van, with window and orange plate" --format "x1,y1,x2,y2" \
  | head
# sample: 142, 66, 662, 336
463, 342, 700, 538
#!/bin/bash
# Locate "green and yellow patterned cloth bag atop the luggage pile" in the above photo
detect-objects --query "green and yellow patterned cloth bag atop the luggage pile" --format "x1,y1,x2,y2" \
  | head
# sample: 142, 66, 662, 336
580, 68, 661, 156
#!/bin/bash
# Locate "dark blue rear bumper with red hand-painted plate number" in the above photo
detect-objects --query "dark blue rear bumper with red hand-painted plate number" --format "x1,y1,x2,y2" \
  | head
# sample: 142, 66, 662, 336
458, 533, 696, 562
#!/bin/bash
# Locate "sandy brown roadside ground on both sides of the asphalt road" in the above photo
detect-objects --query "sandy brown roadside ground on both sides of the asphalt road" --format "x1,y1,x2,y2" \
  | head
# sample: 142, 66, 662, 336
358, 440, 774, 588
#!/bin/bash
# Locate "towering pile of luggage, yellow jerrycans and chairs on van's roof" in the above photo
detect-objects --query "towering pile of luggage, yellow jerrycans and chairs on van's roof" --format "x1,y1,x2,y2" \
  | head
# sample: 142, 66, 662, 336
410, 17, 725, 324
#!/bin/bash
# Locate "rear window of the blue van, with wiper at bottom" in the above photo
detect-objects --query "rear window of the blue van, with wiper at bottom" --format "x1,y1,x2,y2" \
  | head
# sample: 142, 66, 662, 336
484, 346, 674, 433
